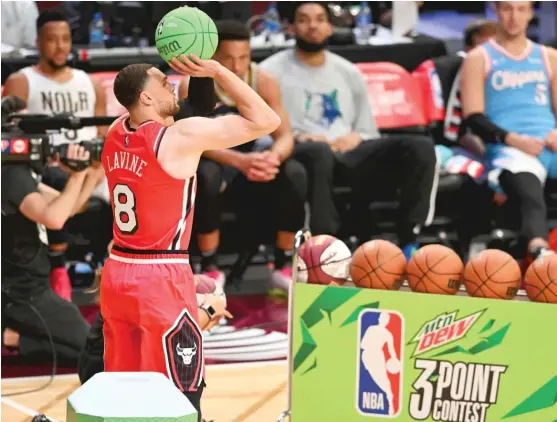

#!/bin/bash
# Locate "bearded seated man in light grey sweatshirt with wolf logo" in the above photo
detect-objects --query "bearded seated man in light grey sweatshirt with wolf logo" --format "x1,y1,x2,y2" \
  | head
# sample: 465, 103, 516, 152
260, 2, 436, 254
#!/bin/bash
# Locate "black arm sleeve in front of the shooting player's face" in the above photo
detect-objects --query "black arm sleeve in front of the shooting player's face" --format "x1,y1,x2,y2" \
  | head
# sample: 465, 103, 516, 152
176, 77, 217, 120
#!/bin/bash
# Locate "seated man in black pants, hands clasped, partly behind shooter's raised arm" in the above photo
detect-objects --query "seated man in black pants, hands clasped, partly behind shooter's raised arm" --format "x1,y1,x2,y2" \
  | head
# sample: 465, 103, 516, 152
180, 21, 307, 290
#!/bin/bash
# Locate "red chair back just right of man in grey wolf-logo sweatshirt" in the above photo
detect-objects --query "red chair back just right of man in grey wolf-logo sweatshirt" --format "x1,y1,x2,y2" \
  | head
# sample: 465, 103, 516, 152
357, 62, 427, 130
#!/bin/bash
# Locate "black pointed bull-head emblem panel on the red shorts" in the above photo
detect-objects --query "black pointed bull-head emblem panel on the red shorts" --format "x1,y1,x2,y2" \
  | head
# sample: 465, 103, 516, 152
163, 309, 204, 391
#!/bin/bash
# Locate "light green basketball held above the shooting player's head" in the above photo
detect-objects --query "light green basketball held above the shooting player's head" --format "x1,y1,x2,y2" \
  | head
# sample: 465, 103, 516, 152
155, 7, 219, 62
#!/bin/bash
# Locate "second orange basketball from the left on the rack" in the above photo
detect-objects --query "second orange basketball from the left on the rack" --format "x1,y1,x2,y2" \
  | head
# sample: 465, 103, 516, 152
407, 245, 464, 295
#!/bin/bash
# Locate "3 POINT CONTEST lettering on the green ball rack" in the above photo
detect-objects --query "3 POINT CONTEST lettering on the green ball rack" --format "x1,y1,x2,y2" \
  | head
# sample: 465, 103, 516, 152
409, 359, 507, 422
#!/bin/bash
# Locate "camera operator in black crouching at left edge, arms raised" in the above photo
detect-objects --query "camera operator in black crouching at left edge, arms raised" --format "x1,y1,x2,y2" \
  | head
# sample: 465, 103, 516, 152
2, 144, 104, 365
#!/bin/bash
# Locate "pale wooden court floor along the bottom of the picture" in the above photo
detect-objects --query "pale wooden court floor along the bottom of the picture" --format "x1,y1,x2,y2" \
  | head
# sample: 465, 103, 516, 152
2, 360, 287, 422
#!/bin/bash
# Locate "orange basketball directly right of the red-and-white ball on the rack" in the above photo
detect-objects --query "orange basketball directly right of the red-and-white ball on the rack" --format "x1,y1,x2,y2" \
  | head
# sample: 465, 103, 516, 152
350, 240, 406, 290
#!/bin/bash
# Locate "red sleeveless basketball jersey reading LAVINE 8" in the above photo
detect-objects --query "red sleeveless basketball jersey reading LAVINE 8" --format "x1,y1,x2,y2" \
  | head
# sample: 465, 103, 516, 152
102, 116, 196, 251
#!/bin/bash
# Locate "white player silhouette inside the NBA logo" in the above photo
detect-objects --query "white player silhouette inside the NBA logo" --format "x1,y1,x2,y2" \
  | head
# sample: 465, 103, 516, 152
361, 312, 400, 415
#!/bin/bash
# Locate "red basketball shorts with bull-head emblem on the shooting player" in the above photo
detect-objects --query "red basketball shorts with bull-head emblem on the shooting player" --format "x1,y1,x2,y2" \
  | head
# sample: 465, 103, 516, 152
101, 249, 204, 392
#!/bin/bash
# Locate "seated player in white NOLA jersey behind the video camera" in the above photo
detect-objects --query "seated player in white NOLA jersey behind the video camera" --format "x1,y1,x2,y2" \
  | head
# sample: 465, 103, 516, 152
3, 11, 106, 300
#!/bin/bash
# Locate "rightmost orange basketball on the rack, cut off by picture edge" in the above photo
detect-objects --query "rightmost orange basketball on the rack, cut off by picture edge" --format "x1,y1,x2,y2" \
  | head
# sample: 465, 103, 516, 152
524, 254, 557, 303
